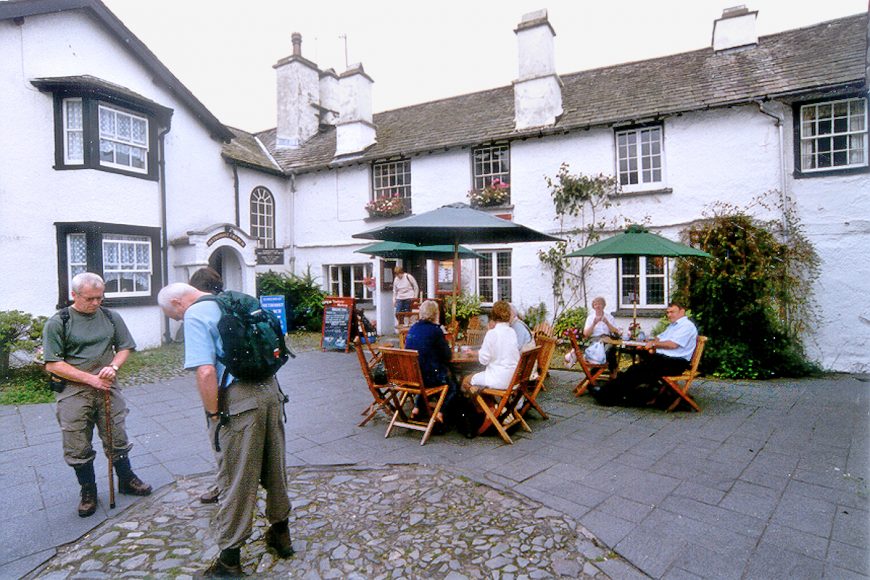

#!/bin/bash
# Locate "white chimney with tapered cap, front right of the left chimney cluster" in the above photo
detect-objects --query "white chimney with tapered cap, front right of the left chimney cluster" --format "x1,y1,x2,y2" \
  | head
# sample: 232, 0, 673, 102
335, 64, 377, 157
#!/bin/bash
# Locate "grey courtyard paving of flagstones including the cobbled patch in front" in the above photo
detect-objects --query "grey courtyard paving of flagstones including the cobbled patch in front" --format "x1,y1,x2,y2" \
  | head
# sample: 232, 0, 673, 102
0, 352, 870, 579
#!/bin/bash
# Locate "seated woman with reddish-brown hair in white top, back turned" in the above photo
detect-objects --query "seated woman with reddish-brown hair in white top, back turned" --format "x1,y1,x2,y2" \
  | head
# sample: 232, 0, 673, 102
463, 300, 520, 391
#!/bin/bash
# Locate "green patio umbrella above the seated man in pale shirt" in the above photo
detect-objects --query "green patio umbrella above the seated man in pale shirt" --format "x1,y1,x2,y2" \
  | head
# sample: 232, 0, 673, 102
565, 224, 713, 325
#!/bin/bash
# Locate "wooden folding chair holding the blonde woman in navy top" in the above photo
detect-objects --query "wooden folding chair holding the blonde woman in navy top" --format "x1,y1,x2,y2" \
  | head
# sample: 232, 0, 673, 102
381, 347, 449, 445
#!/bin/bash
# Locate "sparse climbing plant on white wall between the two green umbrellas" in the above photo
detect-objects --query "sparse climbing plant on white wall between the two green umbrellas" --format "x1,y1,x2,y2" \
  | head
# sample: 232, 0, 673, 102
538, 163, 619, 319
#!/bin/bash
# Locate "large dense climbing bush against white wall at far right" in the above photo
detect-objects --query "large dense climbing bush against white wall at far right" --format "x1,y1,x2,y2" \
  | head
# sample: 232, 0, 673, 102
675, 191, 819, 379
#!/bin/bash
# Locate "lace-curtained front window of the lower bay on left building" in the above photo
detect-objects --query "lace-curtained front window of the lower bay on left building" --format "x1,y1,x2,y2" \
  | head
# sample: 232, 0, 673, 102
103, 234, 153, 298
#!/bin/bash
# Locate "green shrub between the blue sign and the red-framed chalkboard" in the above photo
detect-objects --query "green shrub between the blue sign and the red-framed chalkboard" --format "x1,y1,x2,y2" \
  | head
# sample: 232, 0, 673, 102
257, 267, 326, 331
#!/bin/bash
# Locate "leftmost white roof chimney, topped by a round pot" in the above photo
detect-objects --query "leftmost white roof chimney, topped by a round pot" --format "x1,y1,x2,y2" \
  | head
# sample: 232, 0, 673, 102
273, 32, 320, 149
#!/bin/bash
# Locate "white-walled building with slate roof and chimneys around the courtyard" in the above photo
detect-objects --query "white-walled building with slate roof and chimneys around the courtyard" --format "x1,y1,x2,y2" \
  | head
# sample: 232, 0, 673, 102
0, 0, 870, 372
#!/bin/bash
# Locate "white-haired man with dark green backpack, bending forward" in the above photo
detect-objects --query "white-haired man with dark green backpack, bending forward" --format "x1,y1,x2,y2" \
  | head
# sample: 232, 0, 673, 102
157, 283, 294, 577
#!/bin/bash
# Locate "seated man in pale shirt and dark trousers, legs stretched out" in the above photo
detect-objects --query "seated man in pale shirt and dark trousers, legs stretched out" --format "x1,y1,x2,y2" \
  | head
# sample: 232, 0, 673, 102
590, 302, 698, 405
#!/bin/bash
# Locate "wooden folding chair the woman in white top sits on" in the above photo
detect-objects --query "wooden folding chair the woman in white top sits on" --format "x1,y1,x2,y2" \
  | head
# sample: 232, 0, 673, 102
474, 346, 541, 444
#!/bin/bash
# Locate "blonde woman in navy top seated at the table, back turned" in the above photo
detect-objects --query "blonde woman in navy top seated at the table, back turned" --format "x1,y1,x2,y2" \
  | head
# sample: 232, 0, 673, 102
405, 300, 456, 422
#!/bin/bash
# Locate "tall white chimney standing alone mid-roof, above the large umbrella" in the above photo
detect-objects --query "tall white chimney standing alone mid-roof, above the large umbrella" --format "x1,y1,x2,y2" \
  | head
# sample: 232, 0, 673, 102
514, 10, 562, 130
